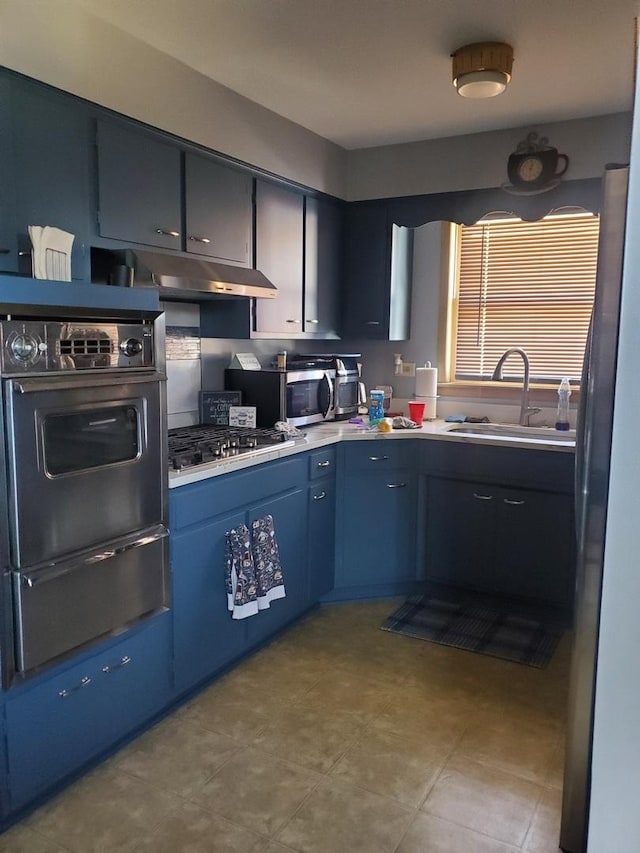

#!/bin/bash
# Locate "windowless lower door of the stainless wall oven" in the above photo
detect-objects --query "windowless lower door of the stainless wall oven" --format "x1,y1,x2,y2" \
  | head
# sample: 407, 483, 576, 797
13, 525, 169, 672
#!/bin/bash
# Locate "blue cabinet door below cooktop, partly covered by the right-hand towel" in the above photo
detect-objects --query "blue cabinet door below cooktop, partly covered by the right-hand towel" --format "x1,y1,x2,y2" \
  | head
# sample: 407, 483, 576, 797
247, 488, 308, 644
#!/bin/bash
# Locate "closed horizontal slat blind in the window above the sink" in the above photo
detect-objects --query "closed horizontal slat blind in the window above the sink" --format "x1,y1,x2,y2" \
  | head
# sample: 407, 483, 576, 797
455, 213, 599, 382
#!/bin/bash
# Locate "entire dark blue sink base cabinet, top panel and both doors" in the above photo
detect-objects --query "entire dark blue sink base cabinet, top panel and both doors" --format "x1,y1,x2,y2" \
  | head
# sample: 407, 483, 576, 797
420, 442, 575, 614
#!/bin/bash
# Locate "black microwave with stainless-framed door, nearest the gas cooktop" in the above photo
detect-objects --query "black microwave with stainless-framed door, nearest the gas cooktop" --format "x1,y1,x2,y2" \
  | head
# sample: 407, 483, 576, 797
224, 368, 336, 427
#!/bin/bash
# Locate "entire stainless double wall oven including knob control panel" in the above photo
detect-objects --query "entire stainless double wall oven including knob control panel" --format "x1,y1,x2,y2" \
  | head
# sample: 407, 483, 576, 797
0, 316, 169, 684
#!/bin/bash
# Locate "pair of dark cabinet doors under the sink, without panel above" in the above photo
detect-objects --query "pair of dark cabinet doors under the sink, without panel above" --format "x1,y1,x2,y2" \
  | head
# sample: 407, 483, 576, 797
425, 477, 575, 608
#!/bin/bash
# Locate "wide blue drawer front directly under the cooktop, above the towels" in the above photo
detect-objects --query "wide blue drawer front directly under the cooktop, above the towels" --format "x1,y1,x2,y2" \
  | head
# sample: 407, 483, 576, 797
170, 453, 307, 530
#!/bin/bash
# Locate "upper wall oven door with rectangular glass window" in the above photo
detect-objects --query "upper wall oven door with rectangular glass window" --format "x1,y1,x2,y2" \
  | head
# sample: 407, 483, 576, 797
5, 372, 166, 569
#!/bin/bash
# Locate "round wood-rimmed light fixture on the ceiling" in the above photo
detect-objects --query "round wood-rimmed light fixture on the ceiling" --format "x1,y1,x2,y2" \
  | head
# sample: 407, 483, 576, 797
451, 41, 513, 98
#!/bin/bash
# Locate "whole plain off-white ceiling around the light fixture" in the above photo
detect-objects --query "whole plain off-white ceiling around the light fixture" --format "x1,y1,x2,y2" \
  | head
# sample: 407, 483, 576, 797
75, 0, 638, 148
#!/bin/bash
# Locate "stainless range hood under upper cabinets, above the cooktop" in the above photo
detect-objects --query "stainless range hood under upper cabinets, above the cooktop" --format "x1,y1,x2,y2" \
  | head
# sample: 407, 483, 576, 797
129, 251, 278, 299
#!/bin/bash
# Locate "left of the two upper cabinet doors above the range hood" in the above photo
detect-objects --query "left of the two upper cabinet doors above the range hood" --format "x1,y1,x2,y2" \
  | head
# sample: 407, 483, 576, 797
98, 121, 182, 249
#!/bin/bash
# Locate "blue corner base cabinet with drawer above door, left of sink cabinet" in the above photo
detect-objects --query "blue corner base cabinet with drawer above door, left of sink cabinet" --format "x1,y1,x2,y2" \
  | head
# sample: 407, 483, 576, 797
335, 439, 417, 597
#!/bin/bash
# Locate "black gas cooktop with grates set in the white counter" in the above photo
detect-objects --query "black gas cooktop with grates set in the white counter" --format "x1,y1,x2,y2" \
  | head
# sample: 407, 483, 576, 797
169, 424, 294, 471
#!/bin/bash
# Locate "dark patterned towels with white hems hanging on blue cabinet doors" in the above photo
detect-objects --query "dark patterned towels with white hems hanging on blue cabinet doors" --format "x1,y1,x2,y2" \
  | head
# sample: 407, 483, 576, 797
225, 515, 286, 619
